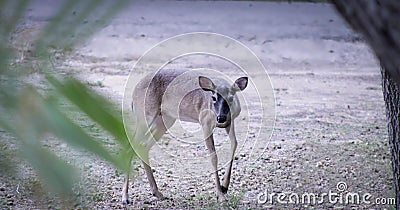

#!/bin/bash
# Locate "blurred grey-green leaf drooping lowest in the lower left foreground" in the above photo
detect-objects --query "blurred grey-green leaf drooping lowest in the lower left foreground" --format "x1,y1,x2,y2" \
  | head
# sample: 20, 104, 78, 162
0, 87, 77, 195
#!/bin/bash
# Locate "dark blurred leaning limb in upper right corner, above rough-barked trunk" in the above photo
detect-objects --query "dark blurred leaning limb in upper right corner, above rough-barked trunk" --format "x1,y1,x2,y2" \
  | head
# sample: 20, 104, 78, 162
333, 0, 400, 82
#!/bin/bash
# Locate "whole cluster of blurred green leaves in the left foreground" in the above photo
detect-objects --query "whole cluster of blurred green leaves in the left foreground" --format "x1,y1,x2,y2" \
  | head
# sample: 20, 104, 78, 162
0, 0, 133, 195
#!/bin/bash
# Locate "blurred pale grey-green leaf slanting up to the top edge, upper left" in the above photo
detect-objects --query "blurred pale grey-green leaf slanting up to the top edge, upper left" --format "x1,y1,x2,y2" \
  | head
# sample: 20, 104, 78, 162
33, 0, 131, 59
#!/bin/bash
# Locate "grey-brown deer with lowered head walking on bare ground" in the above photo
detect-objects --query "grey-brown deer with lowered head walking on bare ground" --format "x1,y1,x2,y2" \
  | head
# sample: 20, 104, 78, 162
122, 69, 248, 204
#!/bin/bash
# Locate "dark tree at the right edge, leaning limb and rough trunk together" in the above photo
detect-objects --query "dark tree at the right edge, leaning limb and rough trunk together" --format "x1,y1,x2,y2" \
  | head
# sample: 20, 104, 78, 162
333, 0, 400, 209
